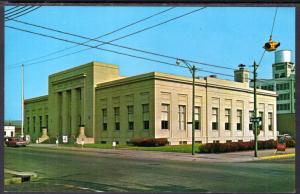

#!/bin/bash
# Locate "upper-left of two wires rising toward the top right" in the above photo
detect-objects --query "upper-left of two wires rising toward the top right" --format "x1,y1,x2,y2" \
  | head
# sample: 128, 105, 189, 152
8, 7, 175, 65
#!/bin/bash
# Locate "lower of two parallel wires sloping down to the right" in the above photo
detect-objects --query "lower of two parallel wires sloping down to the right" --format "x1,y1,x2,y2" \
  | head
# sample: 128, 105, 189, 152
5, 26, 233, 77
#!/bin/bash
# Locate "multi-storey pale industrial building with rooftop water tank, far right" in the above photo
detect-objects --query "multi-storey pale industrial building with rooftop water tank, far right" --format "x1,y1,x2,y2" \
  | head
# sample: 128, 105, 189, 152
253, 50, 296, 137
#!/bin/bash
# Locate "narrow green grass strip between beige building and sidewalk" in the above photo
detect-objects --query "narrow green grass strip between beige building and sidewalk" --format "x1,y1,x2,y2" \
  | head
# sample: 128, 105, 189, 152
63, 144, 200, 153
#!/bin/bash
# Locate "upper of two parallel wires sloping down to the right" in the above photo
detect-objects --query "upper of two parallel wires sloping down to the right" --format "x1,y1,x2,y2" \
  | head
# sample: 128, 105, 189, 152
8, 9, 235, 70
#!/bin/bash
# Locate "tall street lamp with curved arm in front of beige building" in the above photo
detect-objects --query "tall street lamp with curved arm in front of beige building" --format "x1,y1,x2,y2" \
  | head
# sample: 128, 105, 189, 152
176, 59, 199, 155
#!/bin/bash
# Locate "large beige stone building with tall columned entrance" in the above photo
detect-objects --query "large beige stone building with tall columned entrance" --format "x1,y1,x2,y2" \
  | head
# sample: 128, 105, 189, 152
24, 62, 277, 144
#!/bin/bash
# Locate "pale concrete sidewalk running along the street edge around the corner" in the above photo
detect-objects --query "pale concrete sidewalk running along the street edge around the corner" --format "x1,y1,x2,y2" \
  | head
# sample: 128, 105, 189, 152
28, 144, 295, 162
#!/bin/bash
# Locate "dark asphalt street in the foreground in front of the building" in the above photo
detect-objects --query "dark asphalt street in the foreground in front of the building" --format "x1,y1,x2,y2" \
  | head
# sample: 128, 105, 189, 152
4, 147, 295, 192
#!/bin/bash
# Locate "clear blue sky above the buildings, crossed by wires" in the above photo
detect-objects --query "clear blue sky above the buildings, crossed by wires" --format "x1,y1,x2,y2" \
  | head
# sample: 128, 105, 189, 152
5, 6, 295, 120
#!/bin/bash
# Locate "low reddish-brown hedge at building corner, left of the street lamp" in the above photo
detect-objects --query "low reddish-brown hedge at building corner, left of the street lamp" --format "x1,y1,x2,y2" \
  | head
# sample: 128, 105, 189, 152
129, 138, 168, 147
